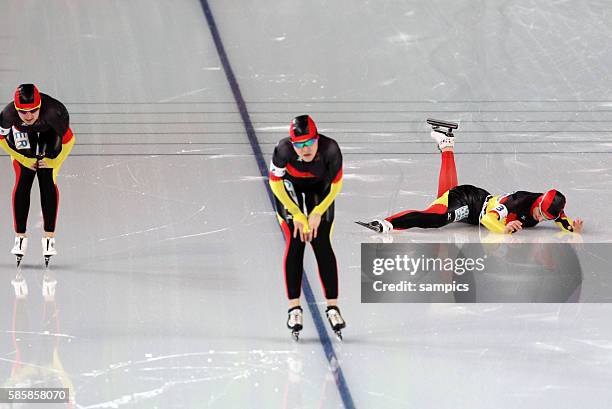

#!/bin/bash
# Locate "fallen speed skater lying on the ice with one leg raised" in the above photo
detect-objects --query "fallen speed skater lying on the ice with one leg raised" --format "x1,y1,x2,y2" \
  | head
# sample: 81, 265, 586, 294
357, 120, 583, 234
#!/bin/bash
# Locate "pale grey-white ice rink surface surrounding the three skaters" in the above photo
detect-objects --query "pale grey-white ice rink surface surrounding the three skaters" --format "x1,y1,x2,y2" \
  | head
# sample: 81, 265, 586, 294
0, 0, 612, 409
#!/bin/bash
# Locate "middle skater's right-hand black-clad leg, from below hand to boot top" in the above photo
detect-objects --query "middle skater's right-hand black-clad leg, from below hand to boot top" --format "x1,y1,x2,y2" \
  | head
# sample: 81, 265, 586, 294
311, 220, 338, 305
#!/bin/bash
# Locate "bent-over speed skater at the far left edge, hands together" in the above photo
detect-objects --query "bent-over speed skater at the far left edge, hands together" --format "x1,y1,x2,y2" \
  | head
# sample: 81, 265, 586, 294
0, 84, 75, 266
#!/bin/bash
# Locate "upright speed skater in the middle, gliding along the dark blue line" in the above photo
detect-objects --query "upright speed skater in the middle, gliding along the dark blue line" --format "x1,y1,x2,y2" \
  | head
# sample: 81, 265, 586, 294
269, 115, 346, 341
